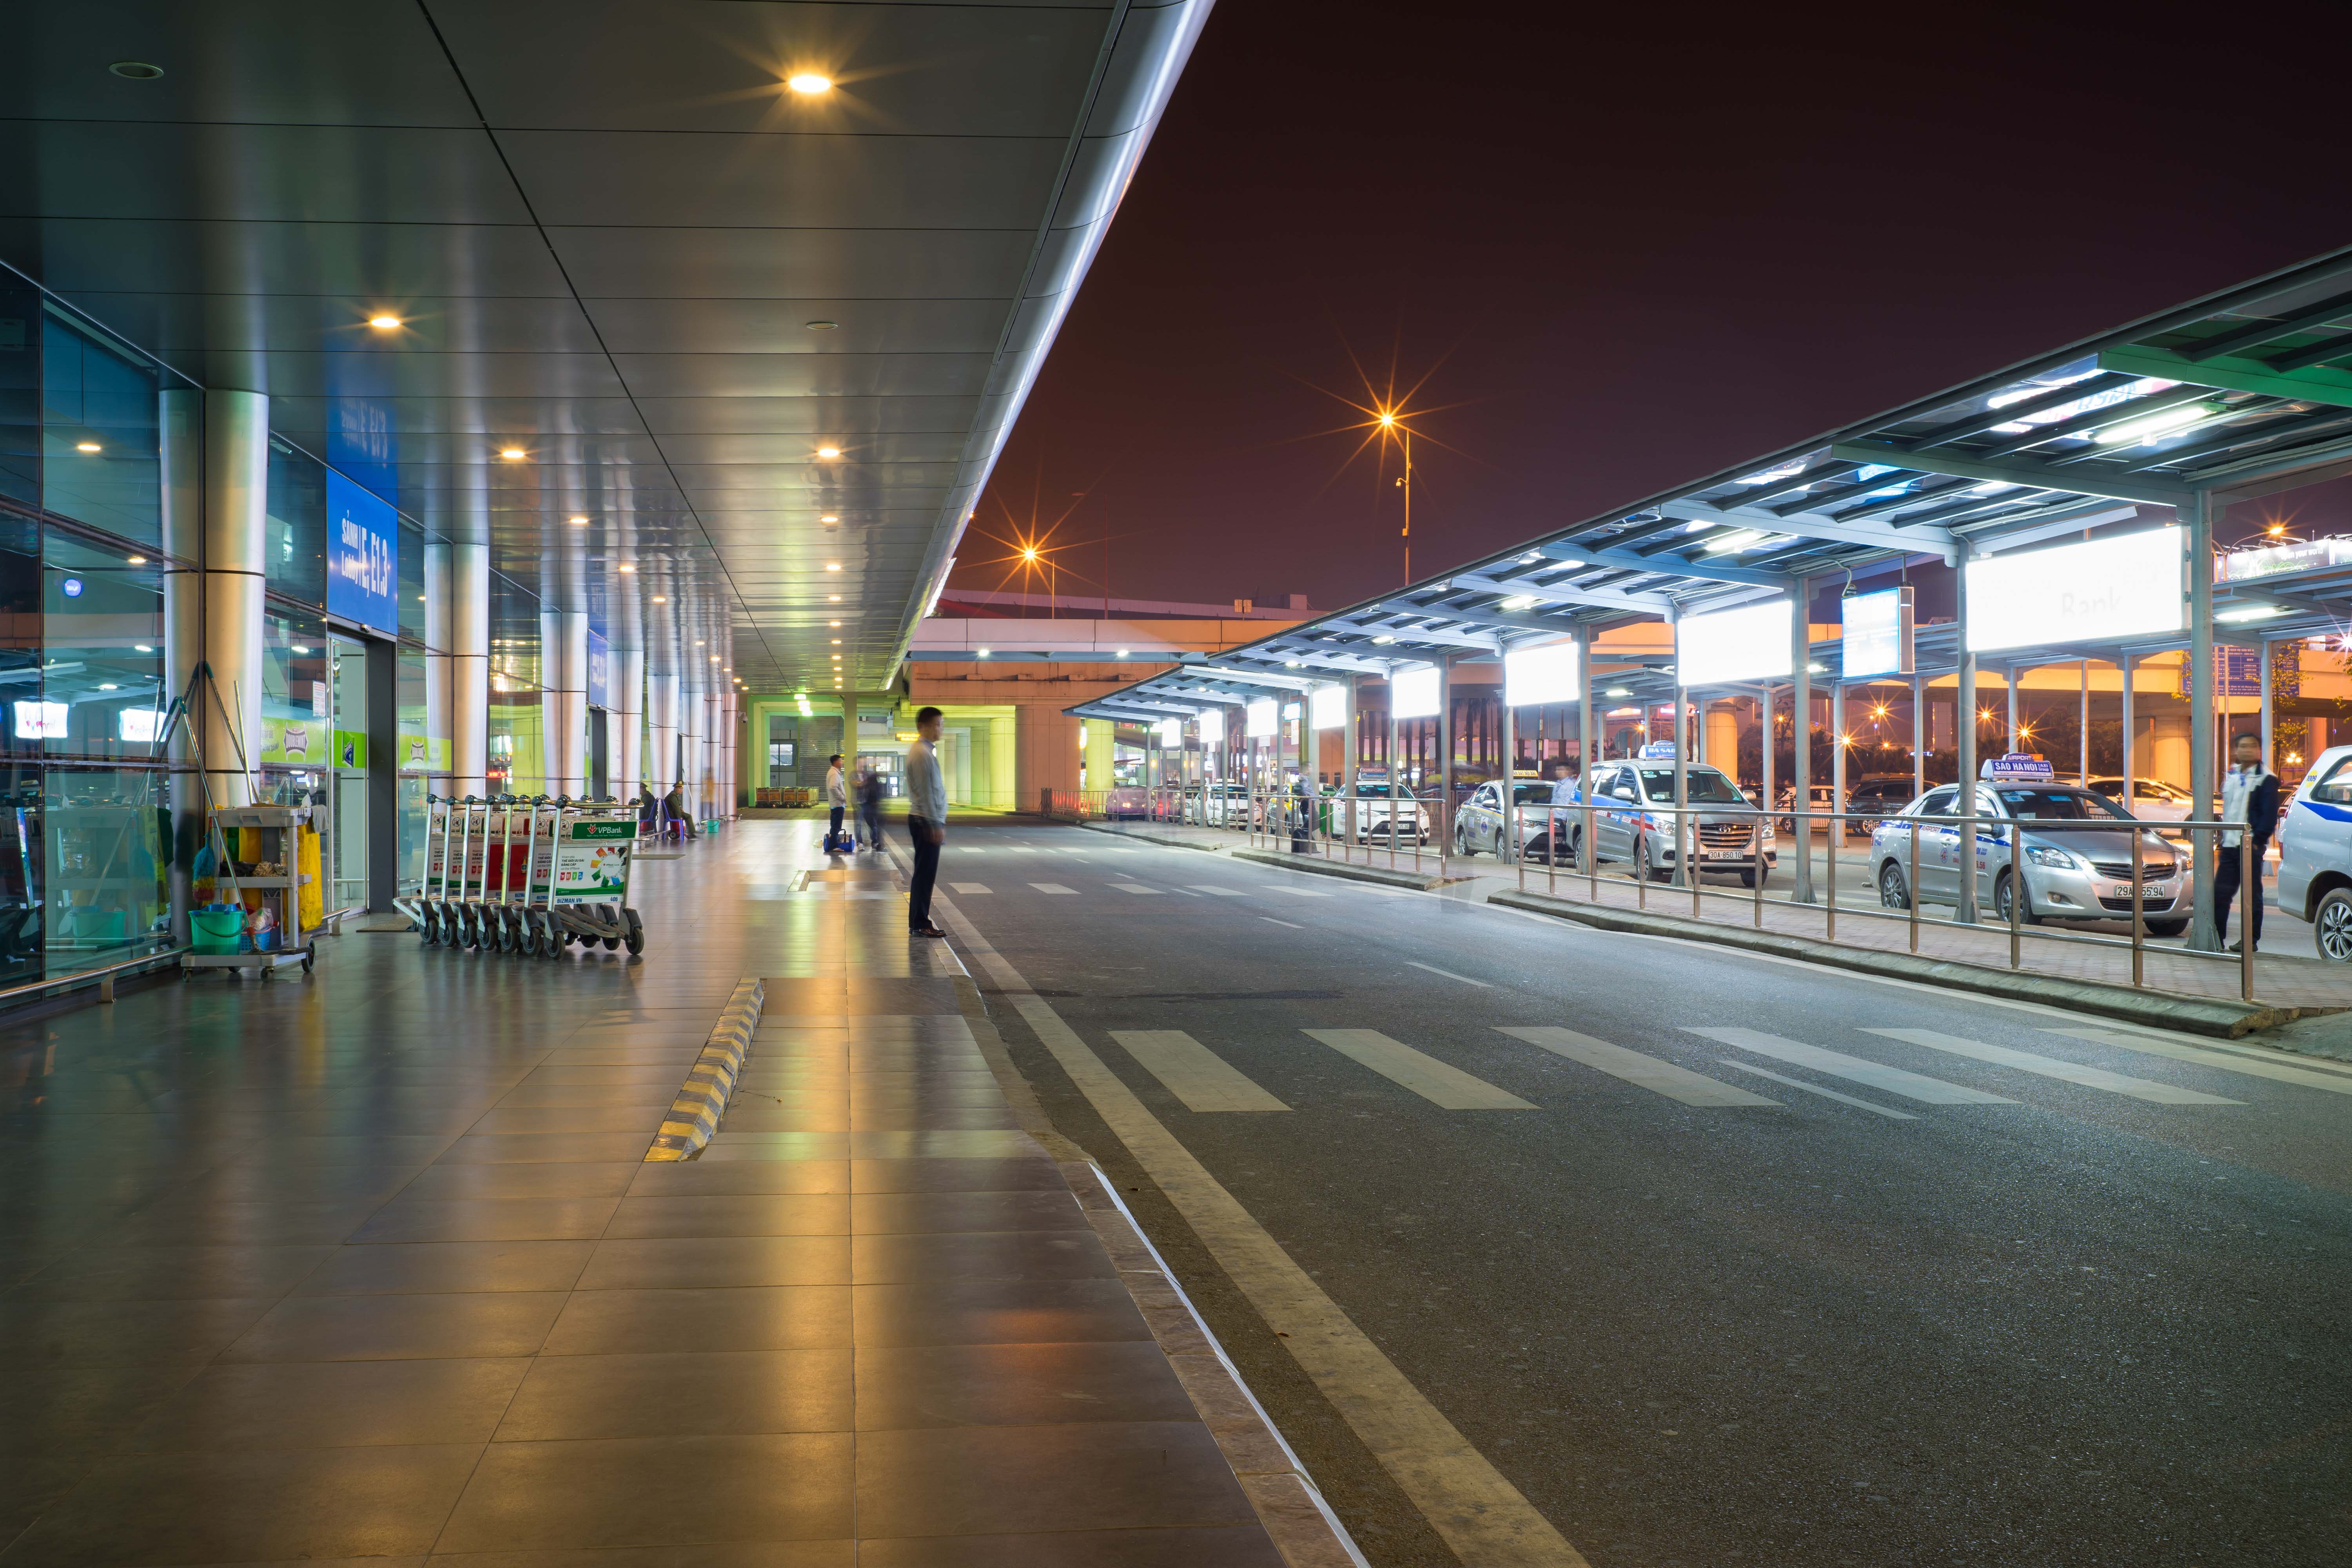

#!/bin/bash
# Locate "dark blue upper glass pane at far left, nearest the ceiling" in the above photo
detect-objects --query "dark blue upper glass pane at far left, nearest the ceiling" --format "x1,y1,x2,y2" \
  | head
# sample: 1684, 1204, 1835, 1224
40, 313, 162, 545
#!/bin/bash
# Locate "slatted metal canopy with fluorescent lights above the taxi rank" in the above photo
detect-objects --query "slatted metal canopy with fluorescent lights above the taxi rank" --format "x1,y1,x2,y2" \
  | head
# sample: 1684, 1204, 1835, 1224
1068, 247, 2352, 717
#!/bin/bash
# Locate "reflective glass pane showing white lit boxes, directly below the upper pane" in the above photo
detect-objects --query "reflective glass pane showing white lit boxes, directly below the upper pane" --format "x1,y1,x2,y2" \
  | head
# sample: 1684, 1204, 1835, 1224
41, 529, 172, 762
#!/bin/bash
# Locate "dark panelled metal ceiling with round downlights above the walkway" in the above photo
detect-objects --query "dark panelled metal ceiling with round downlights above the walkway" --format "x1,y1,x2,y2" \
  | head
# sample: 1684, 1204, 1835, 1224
0, 0, 1211, 691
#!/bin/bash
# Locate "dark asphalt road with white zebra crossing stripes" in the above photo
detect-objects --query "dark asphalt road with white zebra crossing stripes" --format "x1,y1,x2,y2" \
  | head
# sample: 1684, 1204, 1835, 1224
941, 828, 2352, 1568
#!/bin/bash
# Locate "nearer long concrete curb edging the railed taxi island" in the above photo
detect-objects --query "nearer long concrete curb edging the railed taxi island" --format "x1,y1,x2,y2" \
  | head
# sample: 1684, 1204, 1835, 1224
1486, 889, 2328, 1039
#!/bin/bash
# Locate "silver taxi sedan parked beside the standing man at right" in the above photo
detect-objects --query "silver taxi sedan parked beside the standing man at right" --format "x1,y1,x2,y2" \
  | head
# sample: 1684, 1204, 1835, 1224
1870, 778, 2192, 936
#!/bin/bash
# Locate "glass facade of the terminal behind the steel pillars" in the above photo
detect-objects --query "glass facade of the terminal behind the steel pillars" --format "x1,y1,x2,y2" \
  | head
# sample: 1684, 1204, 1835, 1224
0, 273, 593, 1006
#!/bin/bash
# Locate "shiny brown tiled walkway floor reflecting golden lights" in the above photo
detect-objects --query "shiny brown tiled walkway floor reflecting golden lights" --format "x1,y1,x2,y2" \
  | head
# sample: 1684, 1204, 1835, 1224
0, 823, 1282, 1568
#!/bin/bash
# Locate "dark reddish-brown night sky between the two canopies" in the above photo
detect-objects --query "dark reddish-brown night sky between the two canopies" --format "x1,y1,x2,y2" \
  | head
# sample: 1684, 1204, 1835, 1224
955, 0, 2352, 609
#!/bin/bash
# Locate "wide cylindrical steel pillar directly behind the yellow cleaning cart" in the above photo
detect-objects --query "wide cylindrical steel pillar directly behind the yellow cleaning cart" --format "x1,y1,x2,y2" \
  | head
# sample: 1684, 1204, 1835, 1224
202, 390, 270, 806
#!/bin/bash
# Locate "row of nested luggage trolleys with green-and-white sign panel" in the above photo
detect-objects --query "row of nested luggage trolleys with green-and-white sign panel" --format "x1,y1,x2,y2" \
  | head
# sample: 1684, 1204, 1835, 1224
395, 795, 644, 959
